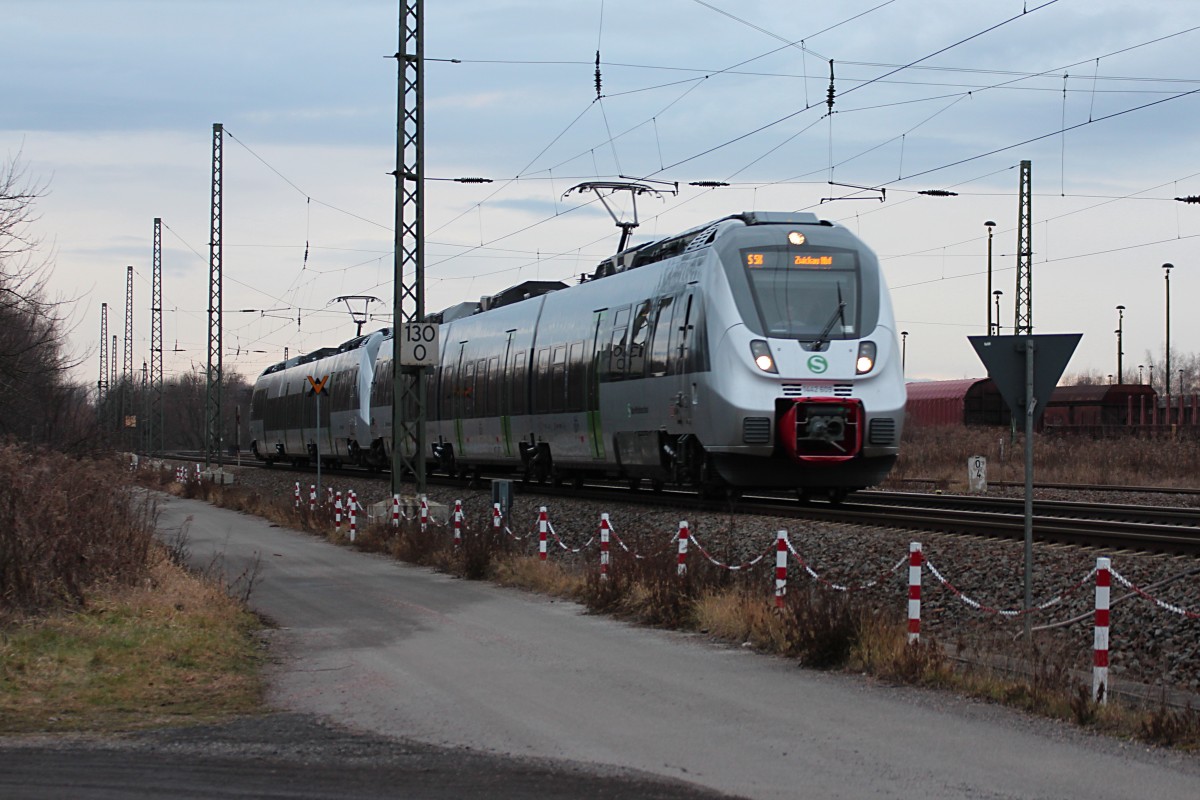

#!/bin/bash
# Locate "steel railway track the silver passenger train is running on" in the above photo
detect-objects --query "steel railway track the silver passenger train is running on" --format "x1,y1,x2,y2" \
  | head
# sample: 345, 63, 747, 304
159, 455, 1200, 555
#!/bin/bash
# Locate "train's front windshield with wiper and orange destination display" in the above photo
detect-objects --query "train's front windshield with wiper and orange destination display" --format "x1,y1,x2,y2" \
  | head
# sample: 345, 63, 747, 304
740, 246, 862, 339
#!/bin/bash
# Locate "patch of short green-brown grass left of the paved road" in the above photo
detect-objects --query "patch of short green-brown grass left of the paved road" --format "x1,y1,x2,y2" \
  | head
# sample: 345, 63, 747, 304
0, 548, 263, 733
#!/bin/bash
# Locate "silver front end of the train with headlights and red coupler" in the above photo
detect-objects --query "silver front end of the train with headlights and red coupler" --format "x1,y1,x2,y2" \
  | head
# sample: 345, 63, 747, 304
709, 213, 905, 498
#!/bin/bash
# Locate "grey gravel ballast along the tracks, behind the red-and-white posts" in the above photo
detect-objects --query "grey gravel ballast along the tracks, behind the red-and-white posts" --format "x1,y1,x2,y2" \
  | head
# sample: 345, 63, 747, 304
206, 468, 1200, 706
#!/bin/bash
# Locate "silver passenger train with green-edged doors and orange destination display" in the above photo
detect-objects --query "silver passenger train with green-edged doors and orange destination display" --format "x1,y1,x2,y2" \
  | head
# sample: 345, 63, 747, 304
250, 212, 905, 499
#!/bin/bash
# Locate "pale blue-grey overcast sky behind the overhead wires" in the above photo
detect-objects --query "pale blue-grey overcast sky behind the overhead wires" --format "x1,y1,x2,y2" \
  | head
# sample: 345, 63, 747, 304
0, 0, 1200, 381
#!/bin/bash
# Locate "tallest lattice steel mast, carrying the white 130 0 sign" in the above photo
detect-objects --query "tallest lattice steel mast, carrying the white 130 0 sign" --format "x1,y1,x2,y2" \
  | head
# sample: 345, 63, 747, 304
391, 0, 425, 494
